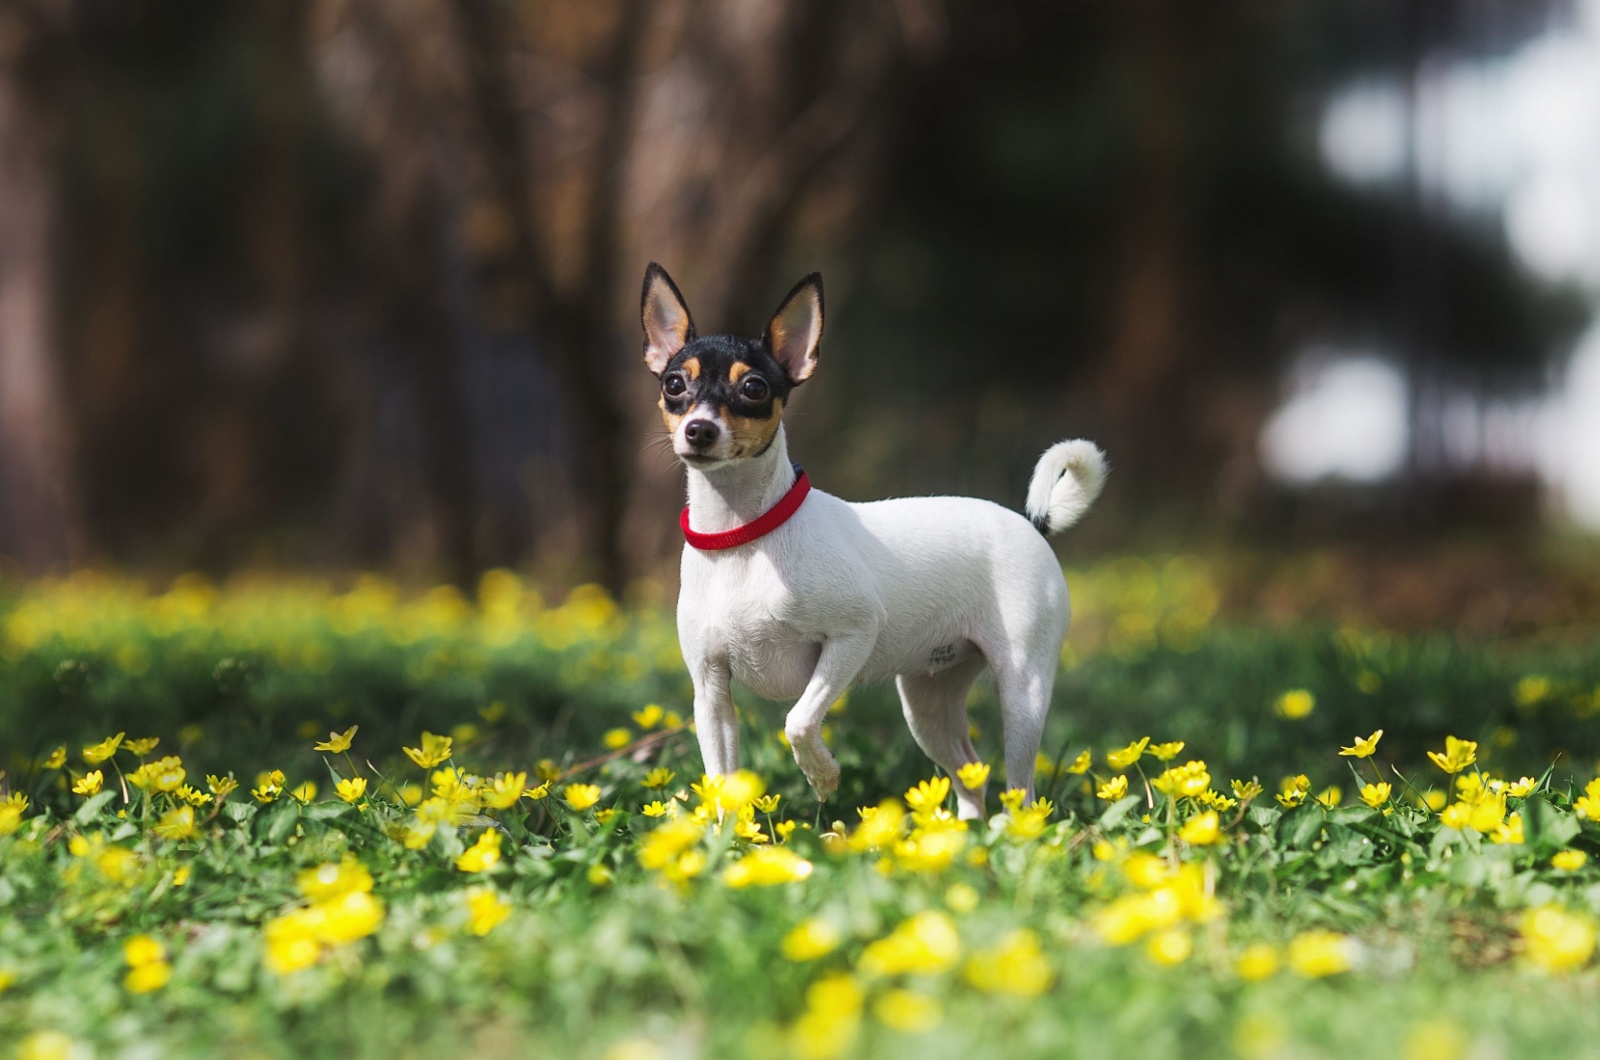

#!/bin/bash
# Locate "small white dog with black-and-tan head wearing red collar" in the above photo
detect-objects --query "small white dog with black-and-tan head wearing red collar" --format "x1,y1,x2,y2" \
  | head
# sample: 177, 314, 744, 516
640, 263, 1107, 820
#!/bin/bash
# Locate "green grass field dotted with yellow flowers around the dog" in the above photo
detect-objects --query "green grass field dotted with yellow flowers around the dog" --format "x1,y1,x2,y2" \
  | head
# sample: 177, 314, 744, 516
0, 570, 1600, 1060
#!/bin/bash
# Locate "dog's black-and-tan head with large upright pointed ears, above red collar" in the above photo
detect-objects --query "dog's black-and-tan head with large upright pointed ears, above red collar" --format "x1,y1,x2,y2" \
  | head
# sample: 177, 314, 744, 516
640, 263, 822, 469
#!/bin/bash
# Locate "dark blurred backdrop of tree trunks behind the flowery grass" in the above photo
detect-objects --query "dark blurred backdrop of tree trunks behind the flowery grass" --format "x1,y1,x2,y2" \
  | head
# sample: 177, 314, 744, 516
0, 0, 1600, 631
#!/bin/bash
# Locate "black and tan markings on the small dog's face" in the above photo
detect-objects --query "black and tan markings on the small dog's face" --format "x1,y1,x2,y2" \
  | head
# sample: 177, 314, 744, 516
661, 335, 790, 460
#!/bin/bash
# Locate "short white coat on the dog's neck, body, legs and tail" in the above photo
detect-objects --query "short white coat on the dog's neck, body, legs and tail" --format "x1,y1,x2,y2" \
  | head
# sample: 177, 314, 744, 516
675, 426, 1106, 818
